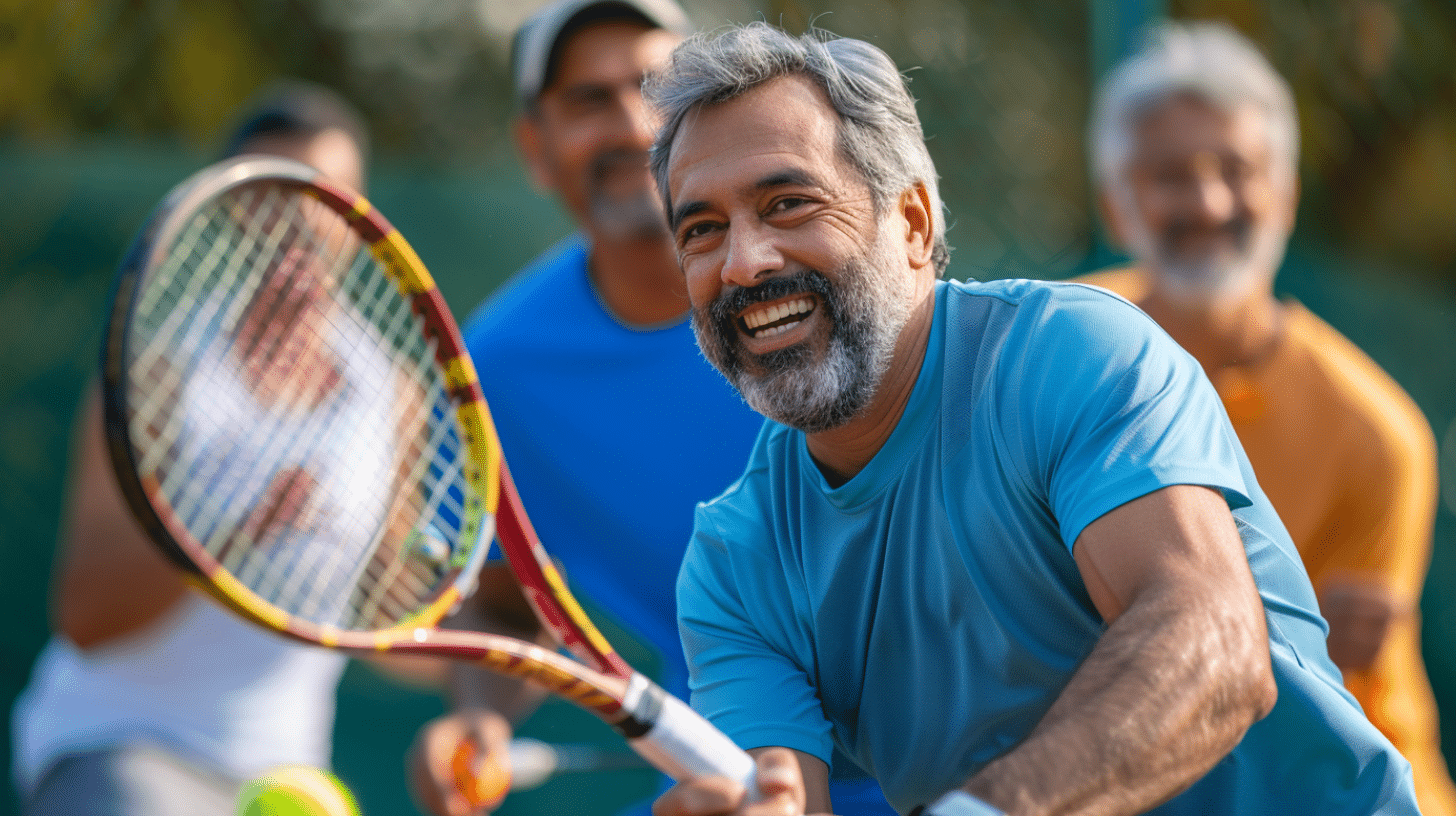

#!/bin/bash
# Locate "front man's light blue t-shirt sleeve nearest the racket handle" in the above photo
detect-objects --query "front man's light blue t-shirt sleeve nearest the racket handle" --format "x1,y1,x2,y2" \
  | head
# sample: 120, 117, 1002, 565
677, 507, 833, 764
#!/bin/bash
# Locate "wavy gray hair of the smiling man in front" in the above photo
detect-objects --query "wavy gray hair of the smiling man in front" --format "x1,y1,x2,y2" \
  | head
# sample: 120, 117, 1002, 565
645, 22, 951, 274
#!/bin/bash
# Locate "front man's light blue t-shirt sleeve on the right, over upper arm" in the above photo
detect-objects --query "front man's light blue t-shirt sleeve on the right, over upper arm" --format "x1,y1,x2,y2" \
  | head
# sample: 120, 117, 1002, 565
994, 286, 1251, 549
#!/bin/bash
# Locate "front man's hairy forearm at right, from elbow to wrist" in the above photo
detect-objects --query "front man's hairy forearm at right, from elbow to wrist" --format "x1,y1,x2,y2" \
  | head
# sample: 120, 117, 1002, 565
965, 582, 1275, 816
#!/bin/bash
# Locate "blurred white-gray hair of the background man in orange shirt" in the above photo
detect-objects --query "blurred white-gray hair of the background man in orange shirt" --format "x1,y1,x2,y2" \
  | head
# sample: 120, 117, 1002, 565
1088, 22, 1299, 185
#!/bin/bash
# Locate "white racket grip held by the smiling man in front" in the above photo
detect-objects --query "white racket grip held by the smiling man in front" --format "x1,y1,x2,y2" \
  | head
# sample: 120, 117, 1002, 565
625, 675, 759, 800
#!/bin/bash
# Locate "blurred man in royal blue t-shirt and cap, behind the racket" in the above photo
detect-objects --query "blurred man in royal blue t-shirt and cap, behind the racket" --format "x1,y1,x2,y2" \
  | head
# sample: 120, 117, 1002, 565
411, 0, 893, 816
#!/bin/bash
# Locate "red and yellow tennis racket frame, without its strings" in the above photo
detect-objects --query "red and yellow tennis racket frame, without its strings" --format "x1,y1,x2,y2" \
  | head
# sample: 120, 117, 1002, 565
103, 156, 632, 721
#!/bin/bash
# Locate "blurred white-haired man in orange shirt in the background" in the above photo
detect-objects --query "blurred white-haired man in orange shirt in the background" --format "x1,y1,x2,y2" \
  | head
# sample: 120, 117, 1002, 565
1083, 23, 1456, 816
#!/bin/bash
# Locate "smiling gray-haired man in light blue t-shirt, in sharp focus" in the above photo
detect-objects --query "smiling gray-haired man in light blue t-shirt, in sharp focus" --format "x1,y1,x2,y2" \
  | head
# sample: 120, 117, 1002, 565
646, 23, 1417, 816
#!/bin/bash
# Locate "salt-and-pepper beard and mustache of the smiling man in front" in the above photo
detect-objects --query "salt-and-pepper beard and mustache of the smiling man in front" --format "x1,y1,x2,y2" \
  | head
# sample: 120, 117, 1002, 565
693, 234, 913, 433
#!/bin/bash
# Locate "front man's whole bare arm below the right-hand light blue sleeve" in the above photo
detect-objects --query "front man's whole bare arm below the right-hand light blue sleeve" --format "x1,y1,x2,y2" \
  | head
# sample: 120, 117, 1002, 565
965, 485, 1277, 816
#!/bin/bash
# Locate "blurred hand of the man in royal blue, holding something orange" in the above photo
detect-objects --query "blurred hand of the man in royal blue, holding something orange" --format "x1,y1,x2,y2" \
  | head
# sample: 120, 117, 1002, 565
408, 708, 511, 816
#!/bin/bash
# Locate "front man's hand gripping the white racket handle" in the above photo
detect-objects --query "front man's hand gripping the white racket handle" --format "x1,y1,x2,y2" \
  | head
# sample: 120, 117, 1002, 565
652, 748, 838, 816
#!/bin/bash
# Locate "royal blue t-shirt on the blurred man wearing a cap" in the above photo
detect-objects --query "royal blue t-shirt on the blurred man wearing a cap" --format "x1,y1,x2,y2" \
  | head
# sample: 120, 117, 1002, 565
462, 238, 890, 815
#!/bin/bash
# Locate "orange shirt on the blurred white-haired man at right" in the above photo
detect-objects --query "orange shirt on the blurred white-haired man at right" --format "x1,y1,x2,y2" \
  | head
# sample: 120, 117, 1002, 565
1077, 270, 1456, 816
